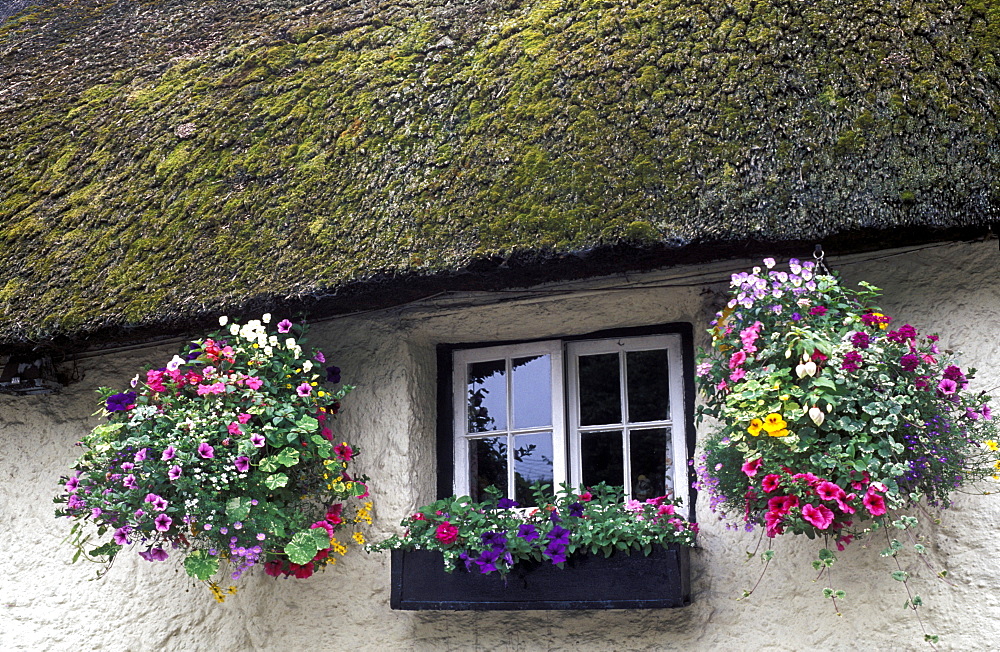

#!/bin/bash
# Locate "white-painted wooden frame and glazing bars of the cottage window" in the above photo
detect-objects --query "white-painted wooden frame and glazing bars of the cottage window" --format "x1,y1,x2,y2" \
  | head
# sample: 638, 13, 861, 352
451, 333, 690, 510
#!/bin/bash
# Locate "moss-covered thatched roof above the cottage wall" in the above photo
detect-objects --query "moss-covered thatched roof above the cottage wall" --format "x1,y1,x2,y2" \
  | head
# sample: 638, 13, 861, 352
0, 0, 1000, 344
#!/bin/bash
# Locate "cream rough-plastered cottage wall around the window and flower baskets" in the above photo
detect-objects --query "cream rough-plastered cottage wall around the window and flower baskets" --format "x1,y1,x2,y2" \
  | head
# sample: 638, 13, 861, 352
0, 242, 1000, 651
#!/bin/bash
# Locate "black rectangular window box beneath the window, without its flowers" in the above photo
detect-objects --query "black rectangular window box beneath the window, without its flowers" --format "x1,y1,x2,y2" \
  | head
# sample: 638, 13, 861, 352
389, 544, 691, 611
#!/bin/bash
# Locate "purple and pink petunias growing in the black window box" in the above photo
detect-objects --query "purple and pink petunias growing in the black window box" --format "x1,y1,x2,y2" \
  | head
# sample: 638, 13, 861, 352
369, 483, 698, 574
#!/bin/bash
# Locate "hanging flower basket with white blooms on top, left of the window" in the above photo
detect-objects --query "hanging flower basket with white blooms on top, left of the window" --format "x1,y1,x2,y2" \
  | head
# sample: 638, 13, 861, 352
55, 315, 371, 602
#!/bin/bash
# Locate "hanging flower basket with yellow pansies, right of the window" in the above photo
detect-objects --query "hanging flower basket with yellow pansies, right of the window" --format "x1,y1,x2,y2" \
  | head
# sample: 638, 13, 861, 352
697, 259, 1000, 636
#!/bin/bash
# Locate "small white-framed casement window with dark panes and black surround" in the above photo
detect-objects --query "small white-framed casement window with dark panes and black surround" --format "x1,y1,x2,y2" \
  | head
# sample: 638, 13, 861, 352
439, 329, 693, 506
